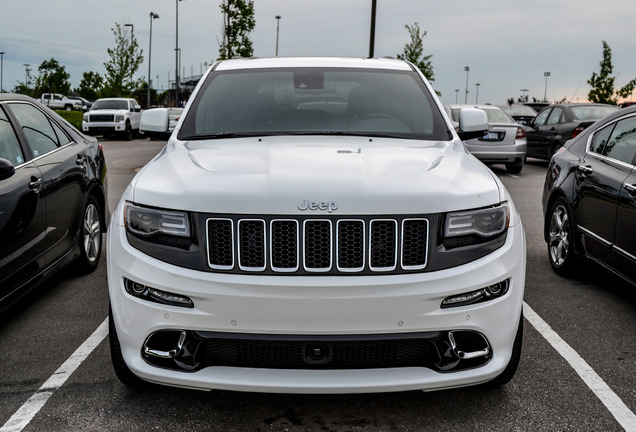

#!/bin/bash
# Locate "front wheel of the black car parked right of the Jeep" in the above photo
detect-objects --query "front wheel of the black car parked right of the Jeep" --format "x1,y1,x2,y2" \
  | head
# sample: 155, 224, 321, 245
548, 198, 577, 276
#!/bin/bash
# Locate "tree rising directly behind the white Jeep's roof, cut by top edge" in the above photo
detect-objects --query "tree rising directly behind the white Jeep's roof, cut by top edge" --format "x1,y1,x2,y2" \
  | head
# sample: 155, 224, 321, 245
219, 0, 256, 60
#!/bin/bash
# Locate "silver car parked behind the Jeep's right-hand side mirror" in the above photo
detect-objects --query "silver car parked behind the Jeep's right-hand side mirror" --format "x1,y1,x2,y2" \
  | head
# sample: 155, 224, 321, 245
446, 105, 526, 174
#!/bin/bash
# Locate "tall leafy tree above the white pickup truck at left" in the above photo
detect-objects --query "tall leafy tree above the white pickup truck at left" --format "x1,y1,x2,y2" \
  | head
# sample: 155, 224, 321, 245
104, 23, 144, 97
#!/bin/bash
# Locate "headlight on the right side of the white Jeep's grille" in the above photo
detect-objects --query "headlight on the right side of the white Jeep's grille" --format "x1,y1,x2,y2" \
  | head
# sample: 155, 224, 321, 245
444, 203, 510, 247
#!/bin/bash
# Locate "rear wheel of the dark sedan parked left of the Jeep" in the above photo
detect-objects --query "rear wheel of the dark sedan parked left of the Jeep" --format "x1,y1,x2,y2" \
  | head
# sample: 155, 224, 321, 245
77, 195, 103, 273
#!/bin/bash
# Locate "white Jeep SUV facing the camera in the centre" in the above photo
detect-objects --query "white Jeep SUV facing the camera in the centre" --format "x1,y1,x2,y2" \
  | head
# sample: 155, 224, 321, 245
107, 57, 526, 393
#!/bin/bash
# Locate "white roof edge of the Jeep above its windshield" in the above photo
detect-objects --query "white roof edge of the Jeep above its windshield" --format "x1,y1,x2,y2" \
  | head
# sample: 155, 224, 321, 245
214, 57, 413, 71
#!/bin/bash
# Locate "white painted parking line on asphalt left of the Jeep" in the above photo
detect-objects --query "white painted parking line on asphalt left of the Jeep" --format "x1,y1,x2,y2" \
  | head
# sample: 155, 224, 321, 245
0, 318, 108, 432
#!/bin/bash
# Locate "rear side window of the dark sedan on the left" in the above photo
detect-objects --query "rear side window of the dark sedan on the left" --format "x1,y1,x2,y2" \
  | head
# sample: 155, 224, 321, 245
10, 103, 68, 157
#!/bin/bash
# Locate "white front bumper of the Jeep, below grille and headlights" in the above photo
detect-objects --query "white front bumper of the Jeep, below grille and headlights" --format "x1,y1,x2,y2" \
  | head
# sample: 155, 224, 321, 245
108, 218, 525, 393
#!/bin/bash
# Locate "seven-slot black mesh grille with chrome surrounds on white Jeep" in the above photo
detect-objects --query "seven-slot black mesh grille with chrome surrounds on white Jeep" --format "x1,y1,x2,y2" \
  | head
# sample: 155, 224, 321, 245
206, 217, 429, 274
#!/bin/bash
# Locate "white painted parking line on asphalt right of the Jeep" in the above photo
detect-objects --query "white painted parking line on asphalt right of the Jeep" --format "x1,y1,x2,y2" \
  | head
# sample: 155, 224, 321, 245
520, 302, 636, 432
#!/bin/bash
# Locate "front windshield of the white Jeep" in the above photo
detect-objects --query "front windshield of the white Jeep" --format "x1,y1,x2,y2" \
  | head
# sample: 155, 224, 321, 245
180, 68, 449, 140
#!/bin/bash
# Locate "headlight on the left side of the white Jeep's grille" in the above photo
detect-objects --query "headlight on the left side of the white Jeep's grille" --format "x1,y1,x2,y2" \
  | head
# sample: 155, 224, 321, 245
124, 203, 190, 243
